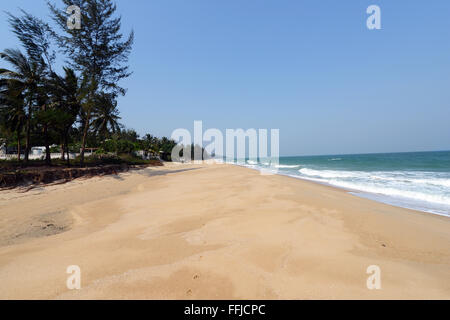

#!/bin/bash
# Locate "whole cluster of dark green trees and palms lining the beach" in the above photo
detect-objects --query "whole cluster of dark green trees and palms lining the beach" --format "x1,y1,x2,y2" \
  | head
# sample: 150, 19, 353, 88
0, 0, 175, 165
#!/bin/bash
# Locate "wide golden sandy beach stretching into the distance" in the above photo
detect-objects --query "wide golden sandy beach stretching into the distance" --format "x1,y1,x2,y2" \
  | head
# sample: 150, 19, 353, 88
0, 165, 450, 299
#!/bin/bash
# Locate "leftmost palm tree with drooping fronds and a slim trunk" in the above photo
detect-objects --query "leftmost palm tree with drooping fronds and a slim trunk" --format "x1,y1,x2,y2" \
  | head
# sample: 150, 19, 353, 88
0, 49, 45, 163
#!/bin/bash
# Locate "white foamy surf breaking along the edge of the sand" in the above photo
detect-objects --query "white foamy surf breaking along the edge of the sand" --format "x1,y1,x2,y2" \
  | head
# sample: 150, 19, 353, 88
223, 160, 450, 216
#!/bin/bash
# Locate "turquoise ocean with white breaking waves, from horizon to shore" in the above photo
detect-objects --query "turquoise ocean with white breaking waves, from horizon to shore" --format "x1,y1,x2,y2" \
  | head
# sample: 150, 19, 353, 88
239, 151, 450, 217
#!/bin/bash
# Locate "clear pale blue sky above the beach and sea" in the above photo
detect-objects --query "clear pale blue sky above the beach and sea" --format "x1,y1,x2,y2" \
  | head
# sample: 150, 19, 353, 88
0, 0, 450, 155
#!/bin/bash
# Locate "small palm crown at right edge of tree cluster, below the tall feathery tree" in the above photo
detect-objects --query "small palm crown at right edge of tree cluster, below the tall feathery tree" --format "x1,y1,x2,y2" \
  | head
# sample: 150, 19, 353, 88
92, 93, 120, 139
